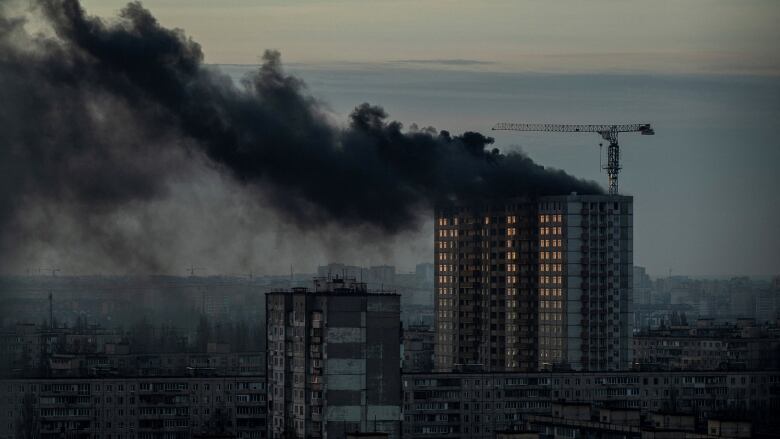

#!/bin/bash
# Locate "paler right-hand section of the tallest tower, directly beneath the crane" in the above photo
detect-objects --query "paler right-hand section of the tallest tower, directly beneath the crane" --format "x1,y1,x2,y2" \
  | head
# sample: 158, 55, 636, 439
539, 195, 633, 371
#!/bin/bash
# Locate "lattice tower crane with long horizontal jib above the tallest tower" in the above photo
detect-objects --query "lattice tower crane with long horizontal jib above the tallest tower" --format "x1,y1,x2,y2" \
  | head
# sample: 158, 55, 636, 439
493, 122, 655, 195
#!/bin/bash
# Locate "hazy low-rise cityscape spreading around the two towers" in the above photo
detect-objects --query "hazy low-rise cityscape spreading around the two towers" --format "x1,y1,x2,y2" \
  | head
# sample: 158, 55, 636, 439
0, 263, 780, 437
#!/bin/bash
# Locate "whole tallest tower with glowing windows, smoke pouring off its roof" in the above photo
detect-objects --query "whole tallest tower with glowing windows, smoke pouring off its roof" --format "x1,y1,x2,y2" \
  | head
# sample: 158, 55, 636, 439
434, 194, 633, 371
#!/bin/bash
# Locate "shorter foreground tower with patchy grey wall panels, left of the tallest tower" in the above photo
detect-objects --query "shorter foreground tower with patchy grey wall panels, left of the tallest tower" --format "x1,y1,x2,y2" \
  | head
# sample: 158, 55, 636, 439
266, 279, 401, 438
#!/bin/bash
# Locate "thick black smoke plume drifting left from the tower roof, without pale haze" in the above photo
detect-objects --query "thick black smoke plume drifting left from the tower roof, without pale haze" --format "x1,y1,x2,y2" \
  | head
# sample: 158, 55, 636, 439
0, 0, 600, 272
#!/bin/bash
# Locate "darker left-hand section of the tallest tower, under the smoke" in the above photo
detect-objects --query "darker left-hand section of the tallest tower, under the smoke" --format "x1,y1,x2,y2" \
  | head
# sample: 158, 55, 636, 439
434, 199, 539, 371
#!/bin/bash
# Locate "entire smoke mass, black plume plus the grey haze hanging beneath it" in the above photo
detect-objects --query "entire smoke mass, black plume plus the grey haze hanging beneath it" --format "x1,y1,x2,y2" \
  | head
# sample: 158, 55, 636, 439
0, 0, 601, 272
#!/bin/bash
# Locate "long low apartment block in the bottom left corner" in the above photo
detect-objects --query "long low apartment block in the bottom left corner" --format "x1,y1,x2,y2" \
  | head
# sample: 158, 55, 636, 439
0, 375, 267, 439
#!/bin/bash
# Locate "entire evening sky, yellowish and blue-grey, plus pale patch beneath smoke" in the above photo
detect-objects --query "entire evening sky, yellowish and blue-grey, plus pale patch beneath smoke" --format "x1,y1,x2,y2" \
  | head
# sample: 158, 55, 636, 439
9, 0, 780, 276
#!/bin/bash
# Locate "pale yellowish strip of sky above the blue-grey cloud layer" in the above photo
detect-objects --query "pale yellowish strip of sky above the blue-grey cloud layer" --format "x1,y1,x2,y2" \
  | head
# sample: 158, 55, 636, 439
84, 0, 780, 74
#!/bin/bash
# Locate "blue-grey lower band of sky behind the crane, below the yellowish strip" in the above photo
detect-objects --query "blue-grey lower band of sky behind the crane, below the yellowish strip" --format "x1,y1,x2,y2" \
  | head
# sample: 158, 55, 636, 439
222, 64, 780, 276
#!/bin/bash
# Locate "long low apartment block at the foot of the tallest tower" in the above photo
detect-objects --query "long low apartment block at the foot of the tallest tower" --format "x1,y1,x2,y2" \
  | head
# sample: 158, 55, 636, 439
403, 371, 780, 439
